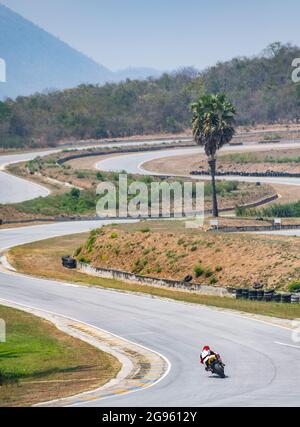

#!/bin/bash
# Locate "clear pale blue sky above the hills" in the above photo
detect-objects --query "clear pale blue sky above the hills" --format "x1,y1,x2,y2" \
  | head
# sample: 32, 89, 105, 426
0, 0, 300, 70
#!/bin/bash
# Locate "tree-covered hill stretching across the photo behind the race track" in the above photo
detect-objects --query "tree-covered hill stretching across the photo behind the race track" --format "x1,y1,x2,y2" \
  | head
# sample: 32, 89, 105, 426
0, 44, 300, 148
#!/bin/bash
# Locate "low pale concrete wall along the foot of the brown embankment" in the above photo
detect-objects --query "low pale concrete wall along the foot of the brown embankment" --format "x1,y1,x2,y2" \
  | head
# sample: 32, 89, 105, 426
77, 262, 234, 298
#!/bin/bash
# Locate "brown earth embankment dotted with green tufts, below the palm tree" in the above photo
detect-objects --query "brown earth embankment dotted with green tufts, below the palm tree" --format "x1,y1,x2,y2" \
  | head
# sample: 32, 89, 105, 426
76, 221, 300, 290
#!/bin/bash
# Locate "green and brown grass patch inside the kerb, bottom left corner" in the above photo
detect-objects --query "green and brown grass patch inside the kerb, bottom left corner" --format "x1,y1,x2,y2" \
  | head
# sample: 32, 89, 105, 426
0, 306, 120, 407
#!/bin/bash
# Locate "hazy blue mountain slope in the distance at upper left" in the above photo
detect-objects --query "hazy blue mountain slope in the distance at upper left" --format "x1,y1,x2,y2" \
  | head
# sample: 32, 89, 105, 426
0, 4, 161, 98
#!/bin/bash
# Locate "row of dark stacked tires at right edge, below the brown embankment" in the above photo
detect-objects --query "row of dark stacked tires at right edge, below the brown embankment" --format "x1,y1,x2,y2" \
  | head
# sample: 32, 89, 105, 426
234, 288, 300, 304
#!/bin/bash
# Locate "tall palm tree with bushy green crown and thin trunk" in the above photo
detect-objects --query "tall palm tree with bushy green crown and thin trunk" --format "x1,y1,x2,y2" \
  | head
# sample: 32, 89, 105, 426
191, 94, 236, 217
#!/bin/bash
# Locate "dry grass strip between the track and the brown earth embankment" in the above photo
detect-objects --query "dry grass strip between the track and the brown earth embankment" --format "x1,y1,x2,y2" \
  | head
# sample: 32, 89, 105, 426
5, 229, 300, 319
